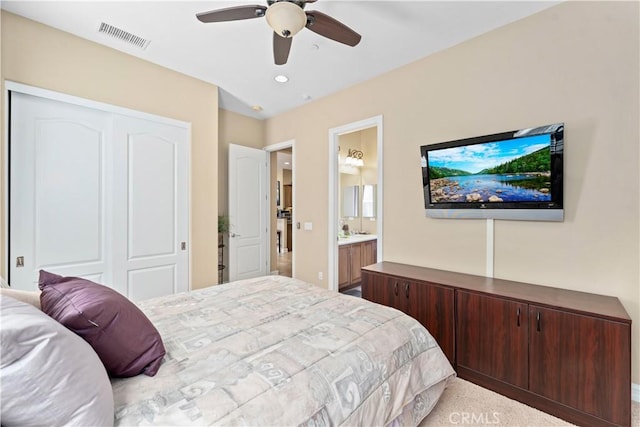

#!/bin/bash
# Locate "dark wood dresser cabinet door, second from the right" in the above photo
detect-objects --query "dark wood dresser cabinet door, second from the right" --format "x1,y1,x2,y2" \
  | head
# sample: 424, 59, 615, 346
456, 291, 528, 389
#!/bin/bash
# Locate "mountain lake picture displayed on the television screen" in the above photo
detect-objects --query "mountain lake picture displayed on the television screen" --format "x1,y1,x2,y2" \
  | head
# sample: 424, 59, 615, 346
427, 134, 551, 203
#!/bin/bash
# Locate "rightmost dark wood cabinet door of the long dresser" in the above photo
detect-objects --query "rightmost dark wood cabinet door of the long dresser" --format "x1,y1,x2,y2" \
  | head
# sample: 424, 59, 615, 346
529, 305, 631, 425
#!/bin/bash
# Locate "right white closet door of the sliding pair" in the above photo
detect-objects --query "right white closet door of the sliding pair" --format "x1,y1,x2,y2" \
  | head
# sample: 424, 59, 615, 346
114, 116, 189, 300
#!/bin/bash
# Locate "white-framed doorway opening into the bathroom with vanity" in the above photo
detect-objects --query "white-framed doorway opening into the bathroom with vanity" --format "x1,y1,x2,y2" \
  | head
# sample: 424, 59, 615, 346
327, 116, 383, 291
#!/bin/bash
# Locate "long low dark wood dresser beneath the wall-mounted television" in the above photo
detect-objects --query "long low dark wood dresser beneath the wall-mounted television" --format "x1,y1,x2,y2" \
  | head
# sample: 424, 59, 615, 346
362, 262, 631, 426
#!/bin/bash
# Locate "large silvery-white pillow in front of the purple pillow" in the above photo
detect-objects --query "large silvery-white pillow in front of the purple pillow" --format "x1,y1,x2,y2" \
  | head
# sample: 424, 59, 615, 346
0, 295, 114, 427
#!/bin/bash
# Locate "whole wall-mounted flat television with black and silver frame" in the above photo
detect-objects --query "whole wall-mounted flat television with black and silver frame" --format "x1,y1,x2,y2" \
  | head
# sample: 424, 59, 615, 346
420, 123, 564, 221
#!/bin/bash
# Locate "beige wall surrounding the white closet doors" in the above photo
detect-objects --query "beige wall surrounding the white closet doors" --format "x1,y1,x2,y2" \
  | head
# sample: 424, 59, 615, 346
1, 11, 218, 288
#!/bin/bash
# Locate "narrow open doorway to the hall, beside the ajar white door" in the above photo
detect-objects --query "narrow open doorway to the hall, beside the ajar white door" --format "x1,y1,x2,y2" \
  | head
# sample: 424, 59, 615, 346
265, 141, 296, 277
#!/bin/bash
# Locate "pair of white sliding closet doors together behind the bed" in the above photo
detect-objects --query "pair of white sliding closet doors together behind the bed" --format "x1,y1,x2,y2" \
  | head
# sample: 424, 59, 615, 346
9, 92, 189, 300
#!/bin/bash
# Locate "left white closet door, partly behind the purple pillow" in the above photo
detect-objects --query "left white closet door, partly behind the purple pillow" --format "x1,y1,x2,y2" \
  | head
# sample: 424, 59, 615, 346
9, 92, 112, 290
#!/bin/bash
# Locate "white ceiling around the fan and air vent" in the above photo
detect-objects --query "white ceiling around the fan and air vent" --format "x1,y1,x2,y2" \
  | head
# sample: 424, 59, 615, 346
1, 0, 558, 119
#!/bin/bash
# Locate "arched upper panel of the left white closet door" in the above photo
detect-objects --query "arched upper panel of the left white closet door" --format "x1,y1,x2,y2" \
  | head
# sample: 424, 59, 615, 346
34, 120, 104, 266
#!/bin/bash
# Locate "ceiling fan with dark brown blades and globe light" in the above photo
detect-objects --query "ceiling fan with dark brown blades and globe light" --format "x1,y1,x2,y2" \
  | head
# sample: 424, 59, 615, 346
196, 0, 362, 65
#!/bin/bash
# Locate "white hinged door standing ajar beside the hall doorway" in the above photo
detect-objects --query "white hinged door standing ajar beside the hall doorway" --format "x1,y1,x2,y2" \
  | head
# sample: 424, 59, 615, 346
228, 144, 268, 281
